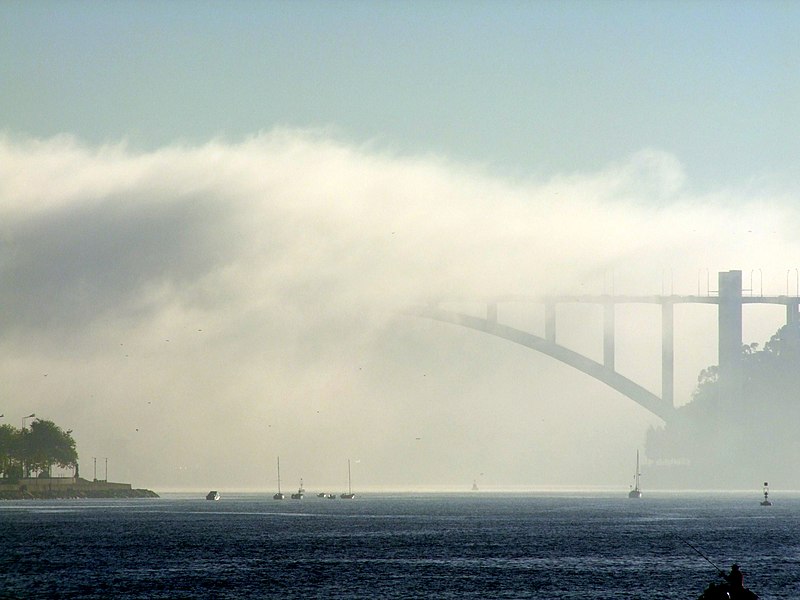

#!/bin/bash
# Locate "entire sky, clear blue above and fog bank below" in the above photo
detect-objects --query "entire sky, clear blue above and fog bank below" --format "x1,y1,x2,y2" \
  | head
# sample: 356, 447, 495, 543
0, 0, 800, 491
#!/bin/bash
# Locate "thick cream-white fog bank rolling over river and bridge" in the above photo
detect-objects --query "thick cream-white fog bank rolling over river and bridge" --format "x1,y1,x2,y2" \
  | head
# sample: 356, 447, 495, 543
0, 129, 800, 491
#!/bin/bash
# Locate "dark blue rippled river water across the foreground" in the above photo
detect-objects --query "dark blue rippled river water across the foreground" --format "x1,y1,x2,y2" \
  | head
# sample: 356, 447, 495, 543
0, 493, 800, 600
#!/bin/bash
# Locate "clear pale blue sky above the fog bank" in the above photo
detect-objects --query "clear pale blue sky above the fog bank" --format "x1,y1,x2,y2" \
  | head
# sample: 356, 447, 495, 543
6, 1, 800, 188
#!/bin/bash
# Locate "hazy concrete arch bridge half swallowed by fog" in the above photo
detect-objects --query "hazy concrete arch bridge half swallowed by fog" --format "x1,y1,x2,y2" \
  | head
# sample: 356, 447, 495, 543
407, 271, 800, 422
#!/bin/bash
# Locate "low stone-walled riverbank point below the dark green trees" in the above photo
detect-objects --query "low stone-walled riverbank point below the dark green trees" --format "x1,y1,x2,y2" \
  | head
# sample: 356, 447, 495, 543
0, 477, 159, 500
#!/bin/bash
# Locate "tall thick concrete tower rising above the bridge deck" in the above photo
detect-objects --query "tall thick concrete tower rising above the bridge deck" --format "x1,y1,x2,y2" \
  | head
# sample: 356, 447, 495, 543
718, 271, 742, 399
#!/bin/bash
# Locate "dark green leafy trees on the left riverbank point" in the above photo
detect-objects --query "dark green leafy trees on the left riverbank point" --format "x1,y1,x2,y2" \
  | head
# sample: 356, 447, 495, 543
0, 419, 78, 481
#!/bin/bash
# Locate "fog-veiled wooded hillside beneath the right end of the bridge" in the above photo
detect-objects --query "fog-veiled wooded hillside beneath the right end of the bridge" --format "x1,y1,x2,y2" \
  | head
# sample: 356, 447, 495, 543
647, 323, 800, 485
